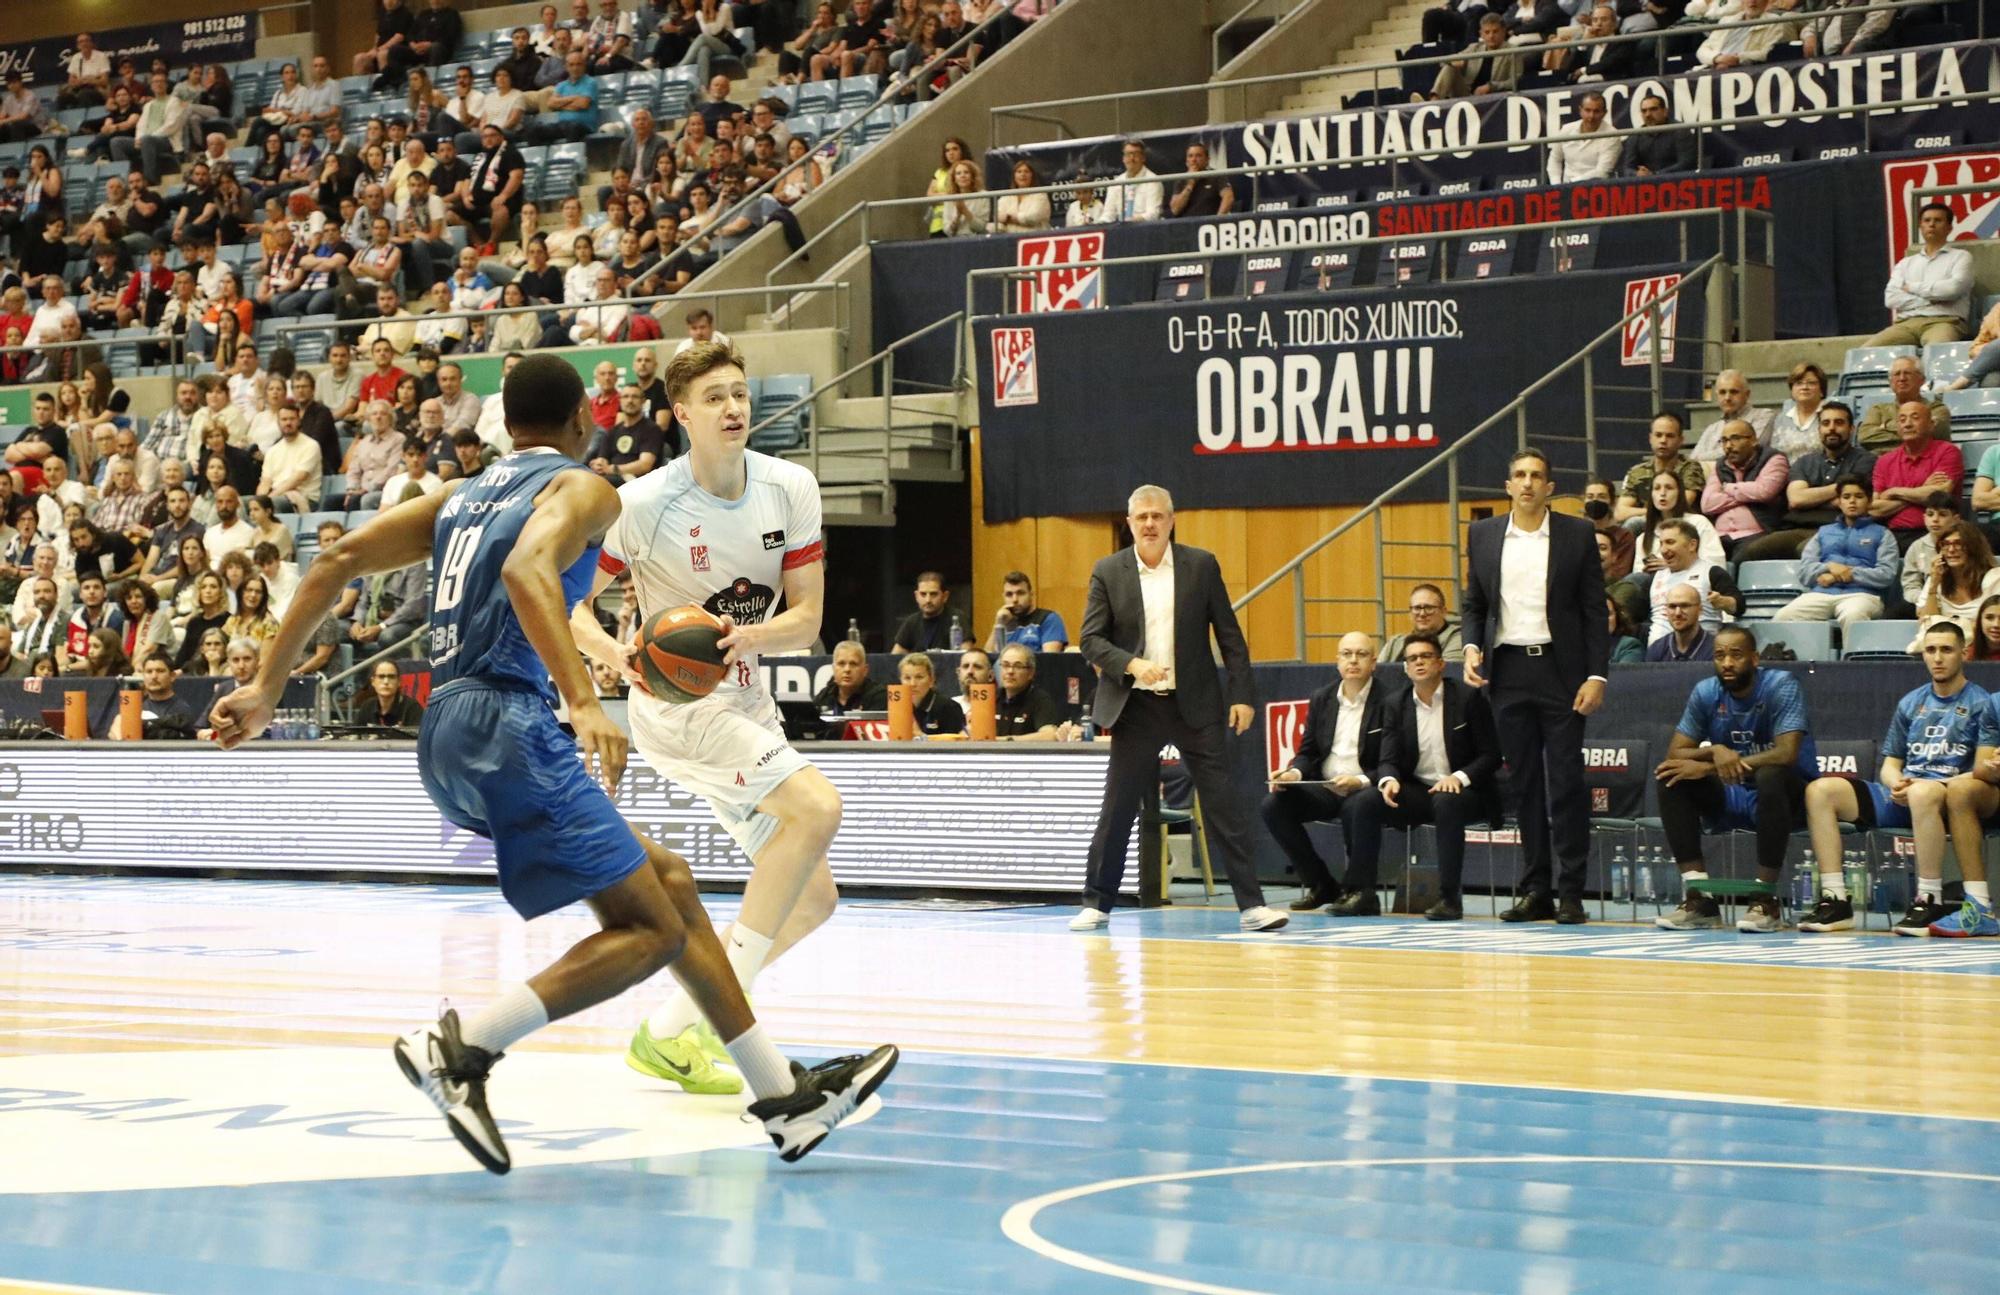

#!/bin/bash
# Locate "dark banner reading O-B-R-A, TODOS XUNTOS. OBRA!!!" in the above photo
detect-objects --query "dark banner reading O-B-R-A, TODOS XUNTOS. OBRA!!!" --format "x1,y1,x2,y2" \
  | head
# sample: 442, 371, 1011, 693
976, 270, 1680, 522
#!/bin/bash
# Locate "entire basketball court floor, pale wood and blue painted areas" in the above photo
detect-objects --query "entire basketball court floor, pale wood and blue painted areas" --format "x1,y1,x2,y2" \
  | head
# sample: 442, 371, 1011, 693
0, 875, 2000, 1295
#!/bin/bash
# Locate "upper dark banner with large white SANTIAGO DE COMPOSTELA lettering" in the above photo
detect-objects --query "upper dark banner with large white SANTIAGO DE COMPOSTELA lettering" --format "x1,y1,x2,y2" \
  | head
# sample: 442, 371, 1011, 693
986, 42, 2000, 194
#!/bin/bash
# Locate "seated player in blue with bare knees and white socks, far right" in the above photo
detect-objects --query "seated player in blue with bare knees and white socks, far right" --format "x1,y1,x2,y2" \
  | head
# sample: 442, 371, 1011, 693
1798, 622, 2000, 935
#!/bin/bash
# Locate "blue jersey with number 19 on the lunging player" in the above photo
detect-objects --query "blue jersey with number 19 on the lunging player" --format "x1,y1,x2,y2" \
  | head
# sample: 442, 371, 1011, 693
430, 448, 600, 703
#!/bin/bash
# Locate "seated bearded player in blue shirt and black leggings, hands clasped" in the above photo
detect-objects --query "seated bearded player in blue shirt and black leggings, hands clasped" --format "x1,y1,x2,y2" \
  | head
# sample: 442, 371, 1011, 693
1654, 626, 1840, 931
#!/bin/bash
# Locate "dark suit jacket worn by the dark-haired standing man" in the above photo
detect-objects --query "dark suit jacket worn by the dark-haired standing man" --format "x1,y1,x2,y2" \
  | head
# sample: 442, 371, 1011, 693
1460, 512, 1612, 691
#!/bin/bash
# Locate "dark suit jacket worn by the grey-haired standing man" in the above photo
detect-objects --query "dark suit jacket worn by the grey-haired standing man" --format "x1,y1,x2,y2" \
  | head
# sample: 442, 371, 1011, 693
1078, 540, 1248, 727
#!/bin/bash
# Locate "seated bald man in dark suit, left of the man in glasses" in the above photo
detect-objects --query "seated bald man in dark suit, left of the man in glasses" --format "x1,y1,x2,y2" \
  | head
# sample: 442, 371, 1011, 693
1262, 632, 1414, 913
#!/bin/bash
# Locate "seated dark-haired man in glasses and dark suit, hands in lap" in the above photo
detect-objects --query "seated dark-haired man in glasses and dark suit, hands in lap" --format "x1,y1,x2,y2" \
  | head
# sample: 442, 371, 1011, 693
1332, 634, 1502, 921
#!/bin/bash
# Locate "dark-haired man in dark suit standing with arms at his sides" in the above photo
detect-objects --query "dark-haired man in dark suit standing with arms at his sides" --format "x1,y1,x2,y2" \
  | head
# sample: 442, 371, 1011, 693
1462, 450, 1610, 925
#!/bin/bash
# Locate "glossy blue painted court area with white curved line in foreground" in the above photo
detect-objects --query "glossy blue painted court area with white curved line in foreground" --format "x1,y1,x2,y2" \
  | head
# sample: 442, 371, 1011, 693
0, 1055, 2000, 1295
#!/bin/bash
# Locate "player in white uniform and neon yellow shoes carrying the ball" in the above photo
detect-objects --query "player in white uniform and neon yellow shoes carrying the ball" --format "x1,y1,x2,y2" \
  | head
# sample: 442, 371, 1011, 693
570, 342, 840, 1093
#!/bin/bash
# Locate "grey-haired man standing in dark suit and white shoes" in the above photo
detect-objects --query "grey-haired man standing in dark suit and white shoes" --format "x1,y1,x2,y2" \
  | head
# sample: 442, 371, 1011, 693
1070, 486, 1286, 931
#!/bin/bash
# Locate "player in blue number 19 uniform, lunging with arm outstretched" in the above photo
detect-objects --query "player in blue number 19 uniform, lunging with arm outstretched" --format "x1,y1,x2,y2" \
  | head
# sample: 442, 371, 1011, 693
212, 356, 896, 1173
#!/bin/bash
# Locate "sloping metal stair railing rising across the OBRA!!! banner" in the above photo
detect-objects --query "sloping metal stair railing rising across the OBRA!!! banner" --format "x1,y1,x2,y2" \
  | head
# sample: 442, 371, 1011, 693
1232, 254, 1726, 661
